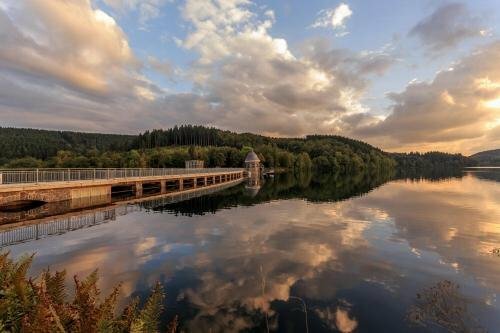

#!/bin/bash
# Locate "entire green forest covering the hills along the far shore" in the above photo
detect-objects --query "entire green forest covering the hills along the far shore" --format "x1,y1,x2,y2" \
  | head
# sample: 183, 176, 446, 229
0, 125, 472, 173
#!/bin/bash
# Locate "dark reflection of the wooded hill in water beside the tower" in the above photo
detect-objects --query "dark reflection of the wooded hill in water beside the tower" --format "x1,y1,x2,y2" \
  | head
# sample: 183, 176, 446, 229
148, 173, 393, 216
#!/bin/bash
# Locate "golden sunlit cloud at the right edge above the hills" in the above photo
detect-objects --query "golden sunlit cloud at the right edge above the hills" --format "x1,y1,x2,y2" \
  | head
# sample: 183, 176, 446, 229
354, 42, 500, 153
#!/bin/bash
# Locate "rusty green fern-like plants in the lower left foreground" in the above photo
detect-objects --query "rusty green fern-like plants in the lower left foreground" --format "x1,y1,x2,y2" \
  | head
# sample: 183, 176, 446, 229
0, 253, 177, 333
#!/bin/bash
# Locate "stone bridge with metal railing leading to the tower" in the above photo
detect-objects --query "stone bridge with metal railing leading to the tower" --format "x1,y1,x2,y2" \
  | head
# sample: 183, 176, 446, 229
0, 168, 244, 207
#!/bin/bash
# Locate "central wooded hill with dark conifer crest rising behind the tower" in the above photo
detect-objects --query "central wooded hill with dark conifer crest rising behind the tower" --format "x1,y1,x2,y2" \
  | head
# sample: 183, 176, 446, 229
134, 125, 395, 173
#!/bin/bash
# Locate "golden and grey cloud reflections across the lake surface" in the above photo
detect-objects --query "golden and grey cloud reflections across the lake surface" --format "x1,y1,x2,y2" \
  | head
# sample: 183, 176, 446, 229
6, 177, 500, 331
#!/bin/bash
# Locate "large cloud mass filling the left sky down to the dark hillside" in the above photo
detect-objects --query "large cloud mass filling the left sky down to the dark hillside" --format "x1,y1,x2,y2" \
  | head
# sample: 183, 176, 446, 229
0, 0, 157, 131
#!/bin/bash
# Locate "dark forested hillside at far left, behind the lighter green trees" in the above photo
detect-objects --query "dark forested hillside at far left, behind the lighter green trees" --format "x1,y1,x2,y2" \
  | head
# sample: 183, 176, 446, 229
0, 127, 136, 165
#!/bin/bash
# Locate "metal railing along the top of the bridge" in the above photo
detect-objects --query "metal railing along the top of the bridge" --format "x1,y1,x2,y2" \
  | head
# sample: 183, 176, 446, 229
0, 168, 243, 185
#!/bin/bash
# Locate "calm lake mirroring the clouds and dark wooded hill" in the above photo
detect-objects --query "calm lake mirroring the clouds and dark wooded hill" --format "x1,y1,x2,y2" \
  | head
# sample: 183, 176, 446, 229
0, 169, 500, 332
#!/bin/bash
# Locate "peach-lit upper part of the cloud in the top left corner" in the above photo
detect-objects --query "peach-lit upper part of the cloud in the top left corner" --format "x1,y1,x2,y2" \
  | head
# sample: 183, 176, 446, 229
0, 0, 138, 94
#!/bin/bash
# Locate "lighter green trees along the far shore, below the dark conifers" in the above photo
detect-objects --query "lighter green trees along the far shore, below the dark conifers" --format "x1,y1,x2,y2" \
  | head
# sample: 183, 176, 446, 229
3, 141, 395, 173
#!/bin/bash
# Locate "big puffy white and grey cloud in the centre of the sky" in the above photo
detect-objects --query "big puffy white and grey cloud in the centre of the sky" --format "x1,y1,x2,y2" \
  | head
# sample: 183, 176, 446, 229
163, 0, 386, 135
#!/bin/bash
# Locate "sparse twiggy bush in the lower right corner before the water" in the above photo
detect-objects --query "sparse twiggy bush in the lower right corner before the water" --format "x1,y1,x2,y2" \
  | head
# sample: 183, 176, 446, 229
408, 280, 486, 333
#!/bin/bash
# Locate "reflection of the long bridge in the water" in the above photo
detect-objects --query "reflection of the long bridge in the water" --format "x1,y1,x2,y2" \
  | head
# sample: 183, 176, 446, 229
0, 180, 241, 248
